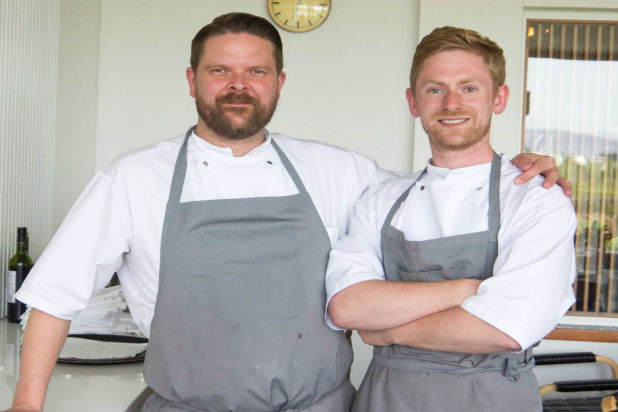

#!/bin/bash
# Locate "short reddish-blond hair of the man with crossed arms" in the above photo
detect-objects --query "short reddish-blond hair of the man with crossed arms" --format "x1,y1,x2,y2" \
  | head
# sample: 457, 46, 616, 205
410, 26, 506, 93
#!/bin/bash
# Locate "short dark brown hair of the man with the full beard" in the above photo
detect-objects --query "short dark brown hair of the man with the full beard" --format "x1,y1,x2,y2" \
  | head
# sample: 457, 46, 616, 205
191, 13, 283, 73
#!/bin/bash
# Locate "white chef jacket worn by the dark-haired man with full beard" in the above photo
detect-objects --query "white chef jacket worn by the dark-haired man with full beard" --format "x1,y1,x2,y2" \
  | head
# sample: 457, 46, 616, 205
17, 133, 390, 336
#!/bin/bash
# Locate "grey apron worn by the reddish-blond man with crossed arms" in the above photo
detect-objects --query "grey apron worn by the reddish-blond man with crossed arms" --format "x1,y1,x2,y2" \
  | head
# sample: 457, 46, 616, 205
352, 154, 541, 412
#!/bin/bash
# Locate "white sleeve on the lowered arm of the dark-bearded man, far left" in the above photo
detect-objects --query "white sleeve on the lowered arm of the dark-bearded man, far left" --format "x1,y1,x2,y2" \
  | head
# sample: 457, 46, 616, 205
17, 167, 131, 320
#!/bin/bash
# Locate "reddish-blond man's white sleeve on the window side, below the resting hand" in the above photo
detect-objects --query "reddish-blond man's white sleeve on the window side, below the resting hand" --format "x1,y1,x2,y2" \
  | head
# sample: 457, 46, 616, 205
462, 186, 577, 349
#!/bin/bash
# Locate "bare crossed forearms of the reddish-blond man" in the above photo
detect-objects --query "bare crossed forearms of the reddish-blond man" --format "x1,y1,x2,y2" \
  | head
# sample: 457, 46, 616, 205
328, 279, 521, 353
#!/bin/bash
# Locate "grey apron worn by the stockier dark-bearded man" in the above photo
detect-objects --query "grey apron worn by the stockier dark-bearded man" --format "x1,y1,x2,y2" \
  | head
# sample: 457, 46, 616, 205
142, 129, 354, 412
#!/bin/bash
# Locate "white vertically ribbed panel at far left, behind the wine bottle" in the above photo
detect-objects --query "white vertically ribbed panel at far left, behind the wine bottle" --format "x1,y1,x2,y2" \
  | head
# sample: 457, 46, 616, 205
0, 0, 60, 317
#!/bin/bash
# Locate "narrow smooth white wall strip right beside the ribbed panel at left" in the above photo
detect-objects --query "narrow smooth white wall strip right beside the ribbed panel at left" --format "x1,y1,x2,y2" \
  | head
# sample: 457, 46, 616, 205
53, 0, 99, 227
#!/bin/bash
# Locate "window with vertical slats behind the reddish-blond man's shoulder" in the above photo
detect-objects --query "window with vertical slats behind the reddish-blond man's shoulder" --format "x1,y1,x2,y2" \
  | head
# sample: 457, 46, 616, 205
523, 19, 618, 315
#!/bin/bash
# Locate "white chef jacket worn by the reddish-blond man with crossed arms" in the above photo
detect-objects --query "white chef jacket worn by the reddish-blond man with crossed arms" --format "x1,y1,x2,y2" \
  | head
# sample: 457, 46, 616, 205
326, 156, 576, 349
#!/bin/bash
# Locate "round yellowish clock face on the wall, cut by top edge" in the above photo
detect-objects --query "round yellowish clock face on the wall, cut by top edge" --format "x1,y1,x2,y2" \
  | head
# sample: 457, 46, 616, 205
267, 0, 330, 32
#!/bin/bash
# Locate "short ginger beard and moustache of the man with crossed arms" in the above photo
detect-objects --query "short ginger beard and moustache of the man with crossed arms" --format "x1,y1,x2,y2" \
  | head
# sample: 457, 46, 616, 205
425, 112, 491, 151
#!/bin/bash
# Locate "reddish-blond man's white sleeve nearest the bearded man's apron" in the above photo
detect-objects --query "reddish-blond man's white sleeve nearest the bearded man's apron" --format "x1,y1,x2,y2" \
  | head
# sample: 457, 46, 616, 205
325, 185, 384, 330
